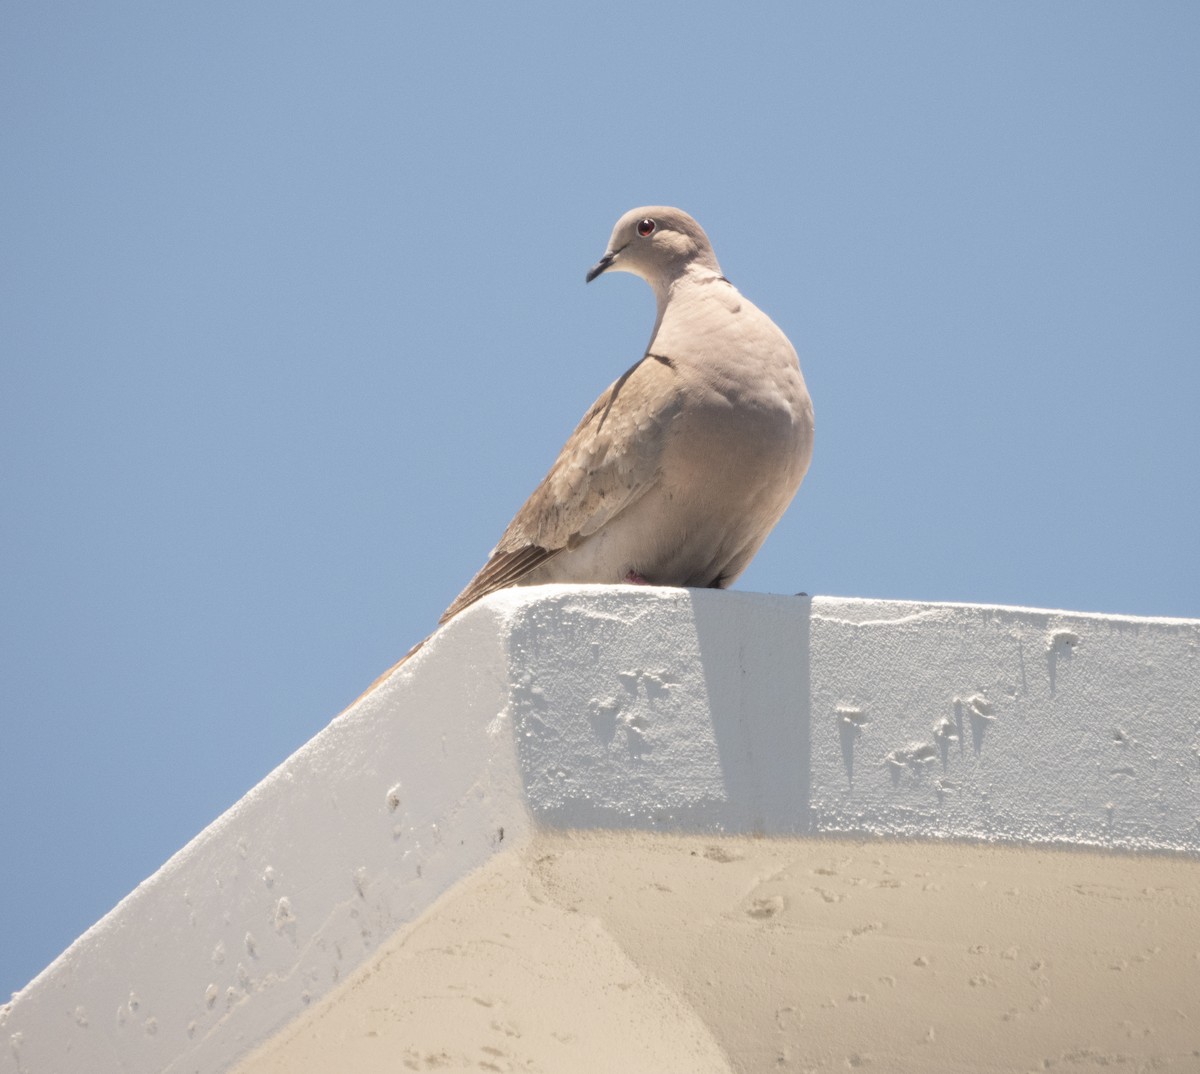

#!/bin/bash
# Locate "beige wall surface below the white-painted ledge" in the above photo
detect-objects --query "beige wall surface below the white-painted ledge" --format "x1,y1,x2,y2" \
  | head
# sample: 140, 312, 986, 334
238, 832, 1200, 1074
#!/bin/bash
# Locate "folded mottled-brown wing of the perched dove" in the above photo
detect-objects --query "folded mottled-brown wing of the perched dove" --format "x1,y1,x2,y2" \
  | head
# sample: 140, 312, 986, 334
439, 355, 683, 623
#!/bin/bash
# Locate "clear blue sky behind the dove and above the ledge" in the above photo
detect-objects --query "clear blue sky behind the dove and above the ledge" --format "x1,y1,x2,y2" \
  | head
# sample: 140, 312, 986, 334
0, 0, 1200, 996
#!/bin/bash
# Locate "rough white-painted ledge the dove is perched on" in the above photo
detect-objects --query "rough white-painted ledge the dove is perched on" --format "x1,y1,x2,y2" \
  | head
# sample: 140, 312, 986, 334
0, 586, 1200, 1074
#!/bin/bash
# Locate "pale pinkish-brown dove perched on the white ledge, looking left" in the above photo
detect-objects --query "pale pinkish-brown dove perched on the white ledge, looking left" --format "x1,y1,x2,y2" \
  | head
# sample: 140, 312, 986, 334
364, 205, 812, 682
